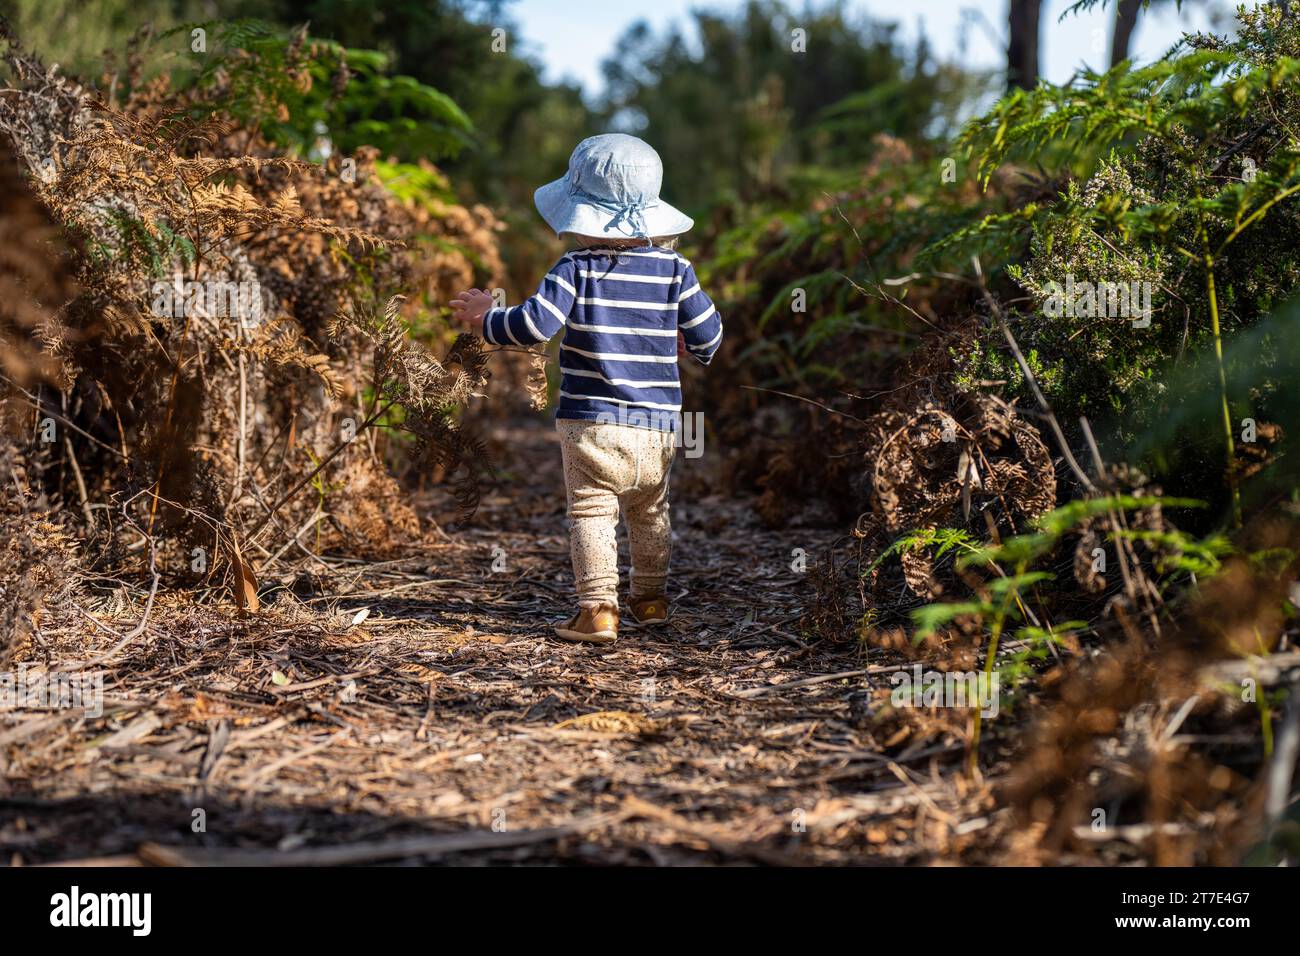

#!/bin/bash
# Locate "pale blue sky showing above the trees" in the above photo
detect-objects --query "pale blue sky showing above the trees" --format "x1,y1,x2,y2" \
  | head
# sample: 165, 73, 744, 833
508, 0, 1235, 95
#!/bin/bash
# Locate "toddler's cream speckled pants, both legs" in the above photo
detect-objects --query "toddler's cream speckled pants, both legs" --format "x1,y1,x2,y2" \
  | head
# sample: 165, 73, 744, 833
555, 419, 676, 607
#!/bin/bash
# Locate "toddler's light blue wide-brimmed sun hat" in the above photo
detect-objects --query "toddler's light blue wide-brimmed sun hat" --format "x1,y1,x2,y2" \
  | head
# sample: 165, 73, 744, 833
533, 133, 696, 238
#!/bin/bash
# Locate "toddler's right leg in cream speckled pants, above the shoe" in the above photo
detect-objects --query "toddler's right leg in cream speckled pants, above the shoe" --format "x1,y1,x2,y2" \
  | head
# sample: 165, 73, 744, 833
621, 428, 676, 600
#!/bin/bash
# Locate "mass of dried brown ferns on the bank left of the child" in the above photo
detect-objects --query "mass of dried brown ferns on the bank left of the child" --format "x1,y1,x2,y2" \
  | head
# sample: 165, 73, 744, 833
0, 23, 501, 582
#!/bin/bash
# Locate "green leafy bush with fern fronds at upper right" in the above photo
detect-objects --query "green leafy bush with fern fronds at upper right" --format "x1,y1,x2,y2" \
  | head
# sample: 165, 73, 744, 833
936, 5, 1300, 515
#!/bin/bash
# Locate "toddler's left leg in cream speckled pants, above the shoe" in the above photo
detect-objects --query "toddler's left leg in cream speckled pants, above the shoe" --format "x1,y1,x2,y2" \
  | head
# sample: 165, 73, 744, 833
555, 419, 619, 607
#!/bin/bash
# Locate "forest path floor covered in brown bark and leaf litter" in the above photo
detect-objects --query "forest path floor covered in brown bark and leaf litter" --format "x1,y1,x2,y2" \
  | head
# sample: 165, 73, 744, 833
0, 420, 1005, 865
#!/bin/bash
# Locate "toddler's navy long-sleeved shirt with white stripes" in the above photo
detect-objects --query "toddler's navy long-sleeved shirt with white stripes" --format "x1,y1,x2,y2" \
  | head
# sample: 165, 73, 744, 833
484, 246, 723, 432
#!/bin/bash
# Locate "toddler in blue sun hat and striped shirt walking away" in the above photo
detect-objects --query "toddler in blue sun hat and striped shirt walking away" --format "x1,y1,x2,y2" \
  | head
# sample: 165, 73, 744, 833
451, 133, 723, 644
